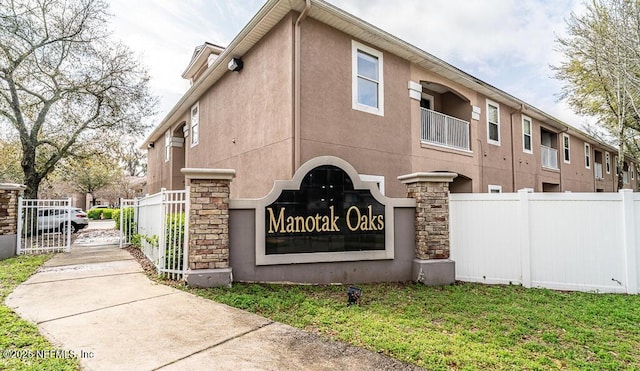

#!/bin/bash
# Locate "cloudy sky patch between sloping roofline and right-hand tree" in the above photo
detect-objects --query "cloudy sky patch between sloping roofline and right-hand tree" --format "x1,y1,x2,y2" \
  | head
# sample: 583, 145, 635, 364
329, 0, 596, 131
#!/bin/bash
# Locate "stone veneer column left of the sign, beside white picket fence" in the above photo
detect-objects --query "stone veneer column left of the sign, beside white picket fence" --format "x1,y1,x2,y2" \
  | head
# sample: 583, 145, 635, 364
181, 168, 236, 287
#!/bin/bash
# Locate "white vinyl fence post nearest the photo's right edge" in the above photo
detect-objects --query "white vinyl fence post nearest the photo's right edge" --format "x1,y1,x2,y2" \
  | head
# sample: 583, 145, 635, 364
619, 189, 638, 294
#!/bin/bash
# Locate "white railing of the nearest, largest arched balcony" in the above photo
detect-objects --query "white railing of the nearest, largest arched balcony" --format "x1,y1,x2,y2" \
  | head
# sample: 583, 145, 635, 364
420, 108, 471, 151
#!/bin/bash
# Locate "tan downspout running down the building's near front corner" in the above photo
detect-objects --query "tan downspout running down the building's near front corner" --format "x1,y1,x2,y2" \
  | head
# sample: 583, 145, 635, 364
291, 0, 311, 176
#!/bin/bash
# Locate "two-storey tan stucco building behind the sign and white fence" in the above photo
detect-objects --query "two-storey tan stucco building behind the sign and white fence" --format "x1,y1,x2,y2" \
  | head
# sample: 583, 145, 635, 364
144, 0, 638, 198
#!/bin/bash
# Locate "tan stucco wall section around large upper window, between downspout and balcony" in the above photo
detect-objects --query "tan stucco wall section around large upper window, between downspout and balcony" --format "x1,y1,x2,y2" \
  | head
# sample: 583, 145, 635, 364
301, 19, 411, 197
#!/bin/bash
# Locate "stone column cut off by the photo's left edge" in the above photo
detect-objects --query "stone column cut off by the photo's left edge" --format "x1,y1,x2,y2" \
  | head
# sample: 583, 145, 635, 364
0, 183, 26, 259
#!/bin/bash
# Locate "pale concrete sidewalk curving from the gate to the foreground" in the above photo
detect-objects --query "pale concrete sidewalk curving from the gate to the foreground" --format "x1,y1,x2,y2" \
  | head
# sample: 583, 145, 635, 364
6, 246, 417, 370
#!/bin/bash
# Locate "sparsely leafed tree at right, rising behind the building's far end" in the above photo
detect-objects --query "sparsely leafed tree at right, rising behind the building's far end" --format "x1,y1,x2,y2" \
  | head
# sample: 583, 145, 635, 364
555, 0, 640, 189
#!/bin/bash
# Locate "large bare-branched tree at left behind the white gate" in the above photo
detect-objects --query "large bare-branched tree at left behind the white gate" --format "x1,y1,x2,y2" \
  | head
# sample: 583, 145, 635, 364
0, 0, 157, 198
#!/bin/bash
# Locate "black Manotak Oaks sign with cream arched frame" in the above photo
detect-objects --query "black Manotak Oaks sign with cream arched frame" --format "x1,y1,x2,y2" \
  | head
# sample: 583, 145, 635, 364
231, 156, 415, 265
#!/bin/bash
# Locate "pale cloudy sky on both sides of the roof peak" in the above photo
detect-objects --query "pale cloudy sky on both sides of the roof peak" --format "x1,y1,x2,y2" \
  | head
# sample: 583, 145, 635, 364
108, 0, 586, 137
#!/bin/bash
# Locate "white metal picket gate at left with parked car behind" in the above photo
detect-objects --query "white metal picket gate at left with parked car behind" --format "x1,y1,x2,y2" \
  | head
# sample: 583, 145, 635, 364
16, 197, 72, 254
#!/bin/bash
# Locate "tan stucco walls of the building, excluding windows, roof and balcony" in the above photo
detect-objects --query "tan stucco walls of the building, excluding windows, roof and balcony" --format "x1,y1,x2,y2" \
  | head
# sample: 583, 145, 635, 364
148, 8, 637, 198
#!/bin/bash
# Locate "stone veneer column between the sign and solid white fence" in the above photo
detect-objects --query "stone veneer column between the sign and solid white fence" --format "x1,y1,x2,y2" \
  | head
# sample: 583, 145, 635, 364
398, 173, 458, 286
